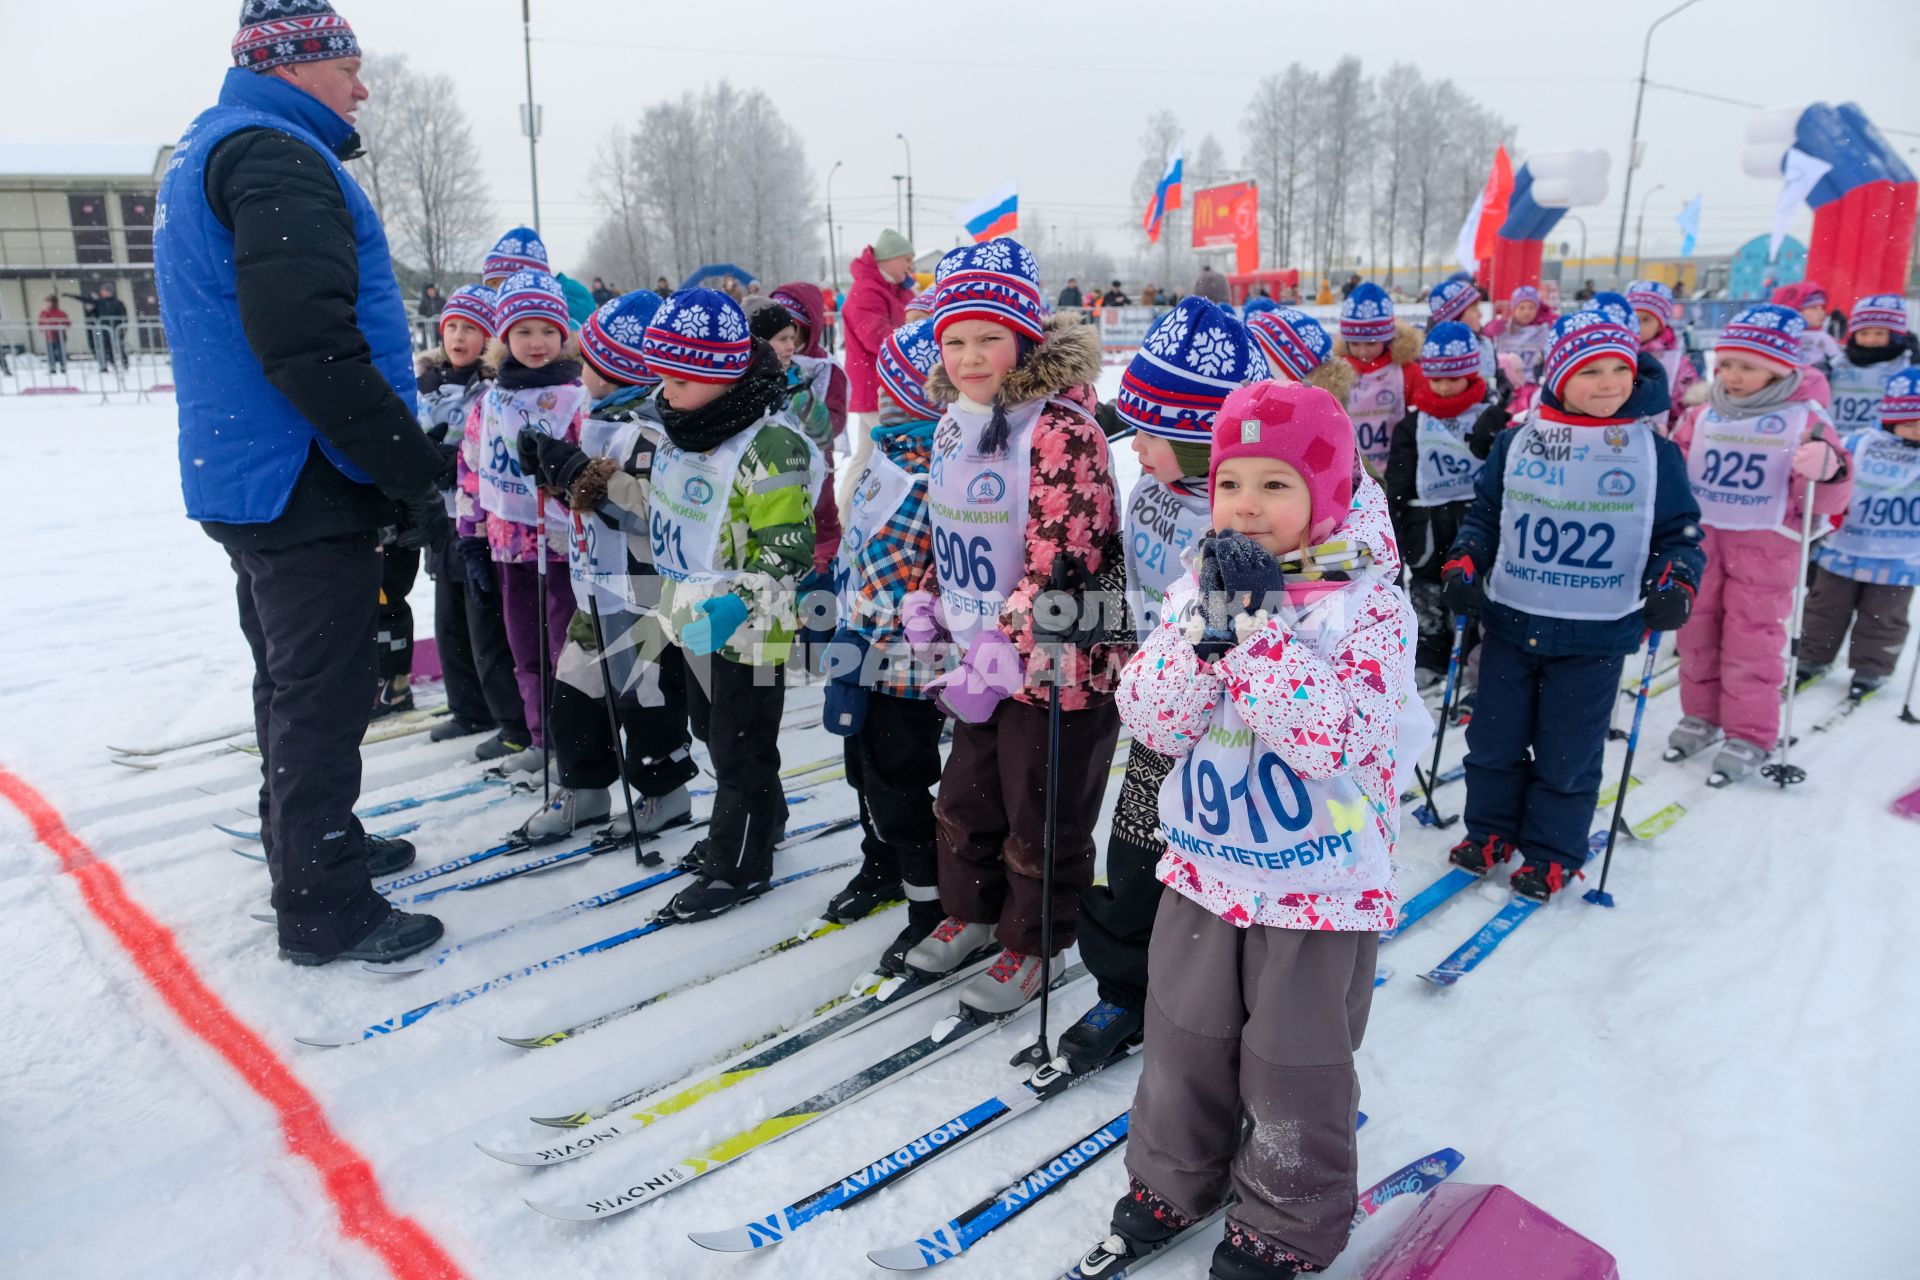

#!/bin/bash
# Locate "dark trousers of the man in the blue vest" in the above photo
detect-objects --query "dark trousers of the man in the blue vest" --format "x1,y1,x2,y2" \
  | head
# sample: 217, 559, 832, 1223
227, 533, 392, 956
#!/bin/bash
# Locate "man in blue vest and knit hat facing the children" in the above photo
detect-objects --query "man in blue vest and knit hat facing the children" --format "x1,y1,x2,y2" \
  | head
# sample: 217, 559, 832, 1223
154, 0, 449, 965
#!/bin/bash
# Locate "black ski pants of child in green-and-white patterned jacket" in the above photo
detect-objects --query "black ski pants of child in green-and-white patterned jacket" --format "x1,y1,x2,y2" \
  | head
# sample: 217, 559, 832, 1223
685, 654, 787, 887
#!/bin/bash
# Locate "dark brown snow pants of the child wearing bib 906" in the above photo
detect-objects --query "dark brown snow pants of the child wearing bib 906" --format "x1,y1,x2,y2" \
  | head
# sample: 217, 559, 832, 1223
933, 699, 1119, 956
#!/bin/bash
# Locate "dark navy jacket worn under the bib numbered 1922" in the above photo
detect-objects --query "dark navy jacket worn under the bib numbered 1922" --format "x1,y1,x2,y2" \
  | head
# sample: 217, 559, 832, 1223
1450, 355, 1707, 658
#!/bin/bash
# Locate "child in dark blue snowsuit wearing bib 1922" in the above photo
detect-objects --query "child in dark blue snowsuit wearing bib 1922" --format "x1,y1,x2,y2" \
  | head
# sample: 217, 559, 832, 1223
1442, 294, 1703, 900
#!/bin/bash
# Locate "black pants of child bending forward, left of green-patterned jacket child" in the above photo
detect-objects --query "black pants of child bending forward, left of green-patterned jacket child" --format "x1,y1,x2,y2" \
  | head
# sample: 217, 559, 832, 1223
547, 647, 701, 796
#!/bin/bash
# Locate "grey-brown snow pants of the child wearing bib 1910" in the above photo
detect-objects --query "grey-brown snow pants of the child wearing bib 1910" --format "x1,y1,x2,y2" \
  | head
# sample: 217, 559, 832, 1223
1127, 892, 1380, 1268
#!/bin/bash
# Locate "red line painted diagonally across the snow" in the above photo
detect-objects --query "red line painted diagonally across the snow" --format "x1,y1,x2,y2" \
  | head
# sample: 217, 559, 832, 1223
0, 768, 465, 1280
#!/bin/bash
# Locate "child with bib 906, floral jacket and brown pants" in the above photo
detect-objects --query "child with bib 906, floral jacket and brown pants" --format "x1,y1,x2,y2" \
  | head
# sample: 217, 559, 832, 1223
904, 236, 1131, 1015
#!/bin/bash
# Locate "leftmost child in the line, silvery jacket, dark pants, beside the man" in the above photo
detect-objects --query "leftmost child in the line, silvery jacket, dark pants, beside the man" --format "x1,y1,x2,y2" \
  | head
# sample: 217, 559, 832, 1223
415, 284, 528, 758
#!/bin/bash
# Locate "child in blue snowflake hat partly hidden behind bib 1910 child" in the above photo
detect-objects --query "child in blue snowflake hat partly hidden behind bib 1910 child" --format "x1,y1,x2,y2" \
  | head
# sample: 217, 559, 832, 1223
1060, 296, 1267, 1071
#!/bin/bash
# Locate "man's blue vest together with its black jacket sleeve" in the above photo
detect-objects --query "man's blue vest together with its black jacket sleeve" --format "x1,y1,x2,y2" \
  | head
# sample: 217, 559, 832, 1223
154, 67, 436, 532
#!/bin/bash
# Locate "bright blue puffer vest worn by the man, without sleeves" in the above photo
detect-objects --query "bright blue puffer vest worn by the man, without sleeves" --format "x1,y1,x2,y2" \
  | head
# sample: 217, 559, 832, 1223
154, 67, 415, 524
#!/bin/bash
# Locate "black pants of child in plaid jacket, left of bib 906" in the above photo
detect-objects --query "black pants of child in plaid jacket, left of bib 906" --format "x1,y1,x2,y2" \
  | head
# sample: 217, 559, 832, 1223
845, 693, 947, 929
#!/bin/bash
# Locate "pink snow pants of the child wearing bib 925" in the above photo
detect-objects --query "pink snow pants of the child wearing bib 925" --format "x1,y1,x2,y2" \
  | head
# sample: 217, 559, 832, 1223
1680, 526, 1799, 750
